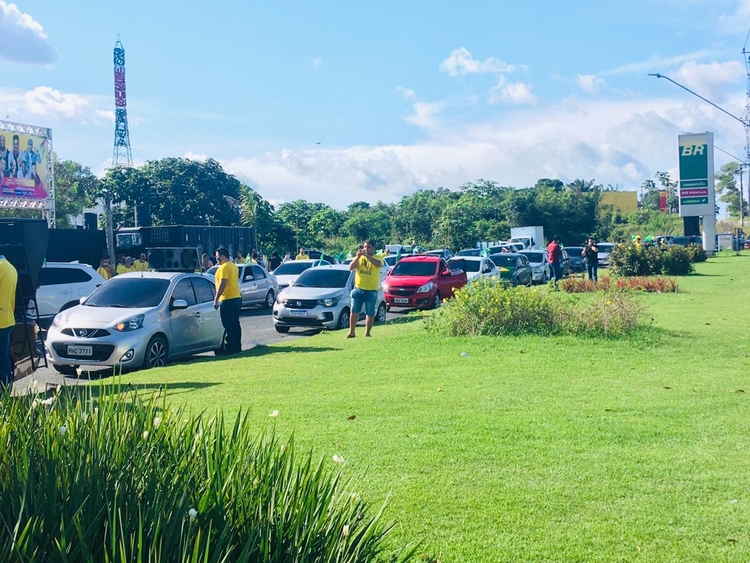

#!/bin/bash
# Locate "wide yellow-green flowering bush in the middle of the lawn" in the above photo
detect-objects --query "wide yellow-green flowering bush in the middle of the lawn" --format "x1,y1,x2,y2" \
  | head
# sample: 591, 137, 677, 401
427, 278, 642, 336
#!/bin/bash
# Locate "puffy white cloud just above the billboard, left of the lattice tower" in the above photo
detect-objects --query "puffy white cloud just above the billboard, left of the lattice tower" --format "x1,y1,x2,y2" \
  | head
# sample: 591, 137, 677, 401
0, 86, 114, 124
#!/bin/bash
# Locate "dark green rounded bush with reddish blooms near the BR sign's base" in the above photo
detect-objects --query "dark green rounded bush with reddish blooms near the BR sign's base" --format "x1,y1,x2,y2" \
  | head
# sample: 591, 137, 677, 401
610, 244, 705, 276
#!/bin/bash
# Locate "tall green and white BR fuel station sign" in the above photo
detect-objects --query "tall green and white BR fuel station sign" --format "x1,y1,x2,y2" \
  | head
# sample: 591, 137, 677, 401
677, 132, 716, 217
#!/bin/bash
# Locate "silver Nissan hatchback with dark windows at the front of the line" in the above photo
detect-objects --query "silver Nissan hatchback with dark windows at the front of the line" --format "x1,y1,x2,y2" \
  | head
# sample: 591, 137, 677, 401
45, 272, 224, 375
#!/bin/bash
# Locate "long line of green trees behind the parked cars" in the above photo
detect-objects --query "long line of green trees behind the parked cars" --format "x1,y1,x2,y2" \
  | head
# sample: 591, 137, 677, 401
10, 153, 740, 253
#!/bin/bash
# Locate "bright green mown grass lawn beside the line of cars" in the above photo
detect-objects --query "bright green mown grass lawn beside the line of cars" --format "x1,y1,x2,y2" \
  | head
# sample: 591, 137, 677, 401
113, 255, 750, 562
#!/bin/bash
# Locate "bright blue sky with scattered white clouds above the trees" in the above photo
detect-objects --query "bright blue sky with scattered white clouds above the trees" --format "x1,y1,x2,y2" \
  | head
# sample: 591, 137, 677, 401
0, 0, 750, 208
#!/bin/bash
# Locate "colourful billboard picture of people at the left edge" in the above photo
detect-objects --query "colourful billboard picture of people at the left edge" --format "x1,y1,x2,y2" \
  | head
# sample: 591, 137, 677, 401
0, 129, 51, 199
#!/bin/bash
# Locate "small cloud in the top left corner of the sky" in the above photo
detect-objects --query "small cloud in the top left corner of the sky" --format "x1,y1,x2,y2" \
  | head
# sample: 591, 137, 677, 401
0, 0, 56, 64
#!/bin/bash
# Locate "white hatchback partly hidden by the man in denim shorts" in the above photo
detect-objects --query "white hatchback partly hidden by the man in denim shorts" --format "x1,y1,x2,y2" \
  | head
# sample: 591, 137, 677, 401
273, 264, 387, 333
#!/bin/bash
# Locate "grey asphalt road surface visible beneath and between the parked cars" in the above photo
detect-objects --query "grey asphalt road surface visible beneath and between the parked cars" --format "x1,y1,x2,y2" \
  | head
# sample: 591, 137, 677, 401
14, 308, 409, 392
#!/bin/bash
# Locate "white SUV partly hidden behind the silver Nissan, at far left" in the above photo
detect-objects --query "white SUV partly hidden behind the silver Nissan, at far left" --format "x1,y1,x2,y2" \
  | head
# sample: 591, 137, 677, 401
35, 262, 105, 328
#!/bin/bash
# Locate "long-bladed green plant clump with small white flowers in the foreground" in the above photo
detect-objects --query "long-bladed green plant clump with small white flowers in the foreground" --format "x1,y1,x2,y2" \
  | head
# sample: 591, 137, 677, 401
0, 386, 420, 563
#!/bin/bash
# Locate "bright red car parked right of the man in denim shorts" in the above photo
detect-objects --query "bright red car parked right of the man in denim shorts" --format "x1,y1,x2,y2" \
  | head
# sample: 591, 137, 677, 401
383, 254, 466, 309
